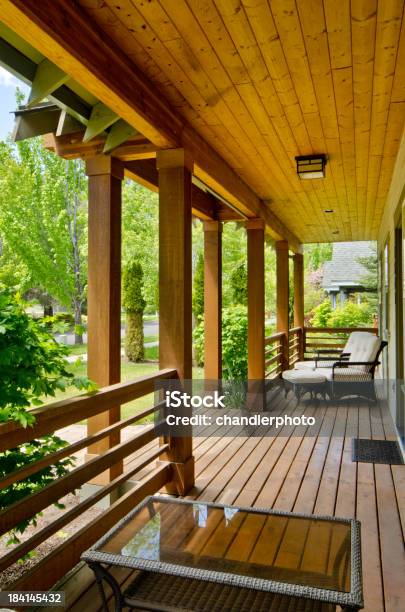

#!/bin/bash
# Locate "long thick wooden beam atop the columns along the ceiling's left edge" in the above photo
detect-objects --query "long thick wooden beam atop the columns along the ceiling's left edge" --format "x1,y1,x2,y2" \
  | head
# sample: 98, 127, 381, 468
0, 0, 299, 250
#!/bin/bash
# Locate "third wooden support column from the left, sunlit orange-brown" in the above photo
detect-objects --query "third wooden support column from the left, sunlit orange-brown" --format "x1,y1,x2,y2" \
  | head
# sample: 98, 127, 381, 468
204, 221, 222, 380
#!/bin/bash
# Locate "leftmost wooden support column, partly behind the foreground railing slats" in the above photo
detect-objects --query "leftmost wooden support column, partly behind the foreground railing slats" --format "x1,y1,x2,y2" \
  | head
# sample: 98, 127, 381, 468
86, 155, 124, 484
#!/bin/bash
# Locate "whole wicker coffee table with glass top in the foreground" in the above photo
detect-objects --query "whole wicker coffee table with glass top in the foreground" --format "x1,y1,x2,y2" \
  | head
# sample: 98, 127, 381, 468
82, 496, 363, 612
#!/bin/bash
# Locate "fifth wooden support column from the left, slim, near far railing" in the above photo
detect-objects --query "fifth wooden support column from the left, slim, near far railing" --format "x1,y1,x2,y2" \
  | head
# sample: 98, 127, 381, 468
276, 240, 290, 370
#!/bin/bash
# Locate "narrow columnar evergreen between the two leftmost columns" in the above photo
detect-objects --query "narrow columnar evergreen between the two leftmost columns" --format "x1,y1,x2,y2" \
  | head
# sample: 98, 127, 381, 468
123, 260, 146, 361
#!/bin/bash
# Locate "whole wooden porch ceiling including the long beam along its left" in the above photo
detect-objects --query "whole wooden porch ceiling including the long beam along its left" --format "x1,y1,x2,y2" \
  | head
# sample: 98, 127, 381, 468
0, 0, 405, 249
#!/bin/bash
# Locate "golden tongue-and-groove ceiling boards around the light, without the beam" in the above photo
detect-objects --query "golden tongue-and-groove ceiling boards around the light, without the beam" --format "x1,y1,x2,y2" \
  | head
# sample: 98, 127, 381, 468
70, 0, 405, 242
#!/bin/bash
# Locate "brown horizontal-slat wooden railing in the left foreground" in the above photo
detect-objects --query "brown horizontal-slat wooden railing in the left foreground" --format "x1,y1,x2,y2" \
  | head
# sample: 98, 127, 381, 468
0, 369, 177, 590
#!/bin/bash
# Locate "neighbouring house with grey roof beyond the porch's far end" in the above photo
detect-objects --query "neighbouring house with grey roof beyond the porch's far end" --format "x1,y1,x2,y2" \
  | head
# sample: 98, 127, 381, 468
322, 242, 375, 308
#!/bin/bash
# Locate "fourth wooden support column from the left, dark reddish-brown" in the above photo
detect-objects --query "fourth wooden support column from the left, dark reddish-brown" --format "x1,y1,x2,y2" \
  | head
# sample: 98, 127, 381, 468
246, 219, 265, 381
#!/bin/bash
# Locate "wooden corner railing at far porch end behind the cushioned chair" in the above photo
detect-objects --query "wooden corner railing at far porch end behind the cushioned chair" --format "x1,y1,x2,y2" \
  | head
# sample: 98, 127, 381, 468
265, 327, 378, 379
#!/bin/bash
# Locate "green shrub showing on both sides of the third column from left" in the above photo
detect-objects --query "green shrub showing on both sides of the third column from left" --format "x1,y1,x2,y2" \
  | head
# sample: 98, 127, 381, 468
194, 305, 247, 380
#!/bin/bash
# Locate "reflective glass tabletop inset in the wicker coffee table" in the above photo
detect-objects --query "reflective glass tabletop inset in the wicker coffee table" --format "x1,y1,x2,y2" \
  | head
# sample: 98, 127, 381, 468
95, 498, 351, 593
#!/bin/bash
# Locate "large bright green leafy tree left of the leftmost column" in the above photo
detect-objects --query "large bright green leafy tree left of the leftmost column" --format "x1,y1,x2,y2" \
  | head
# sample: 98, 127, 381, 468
0, 138, 87, 342
